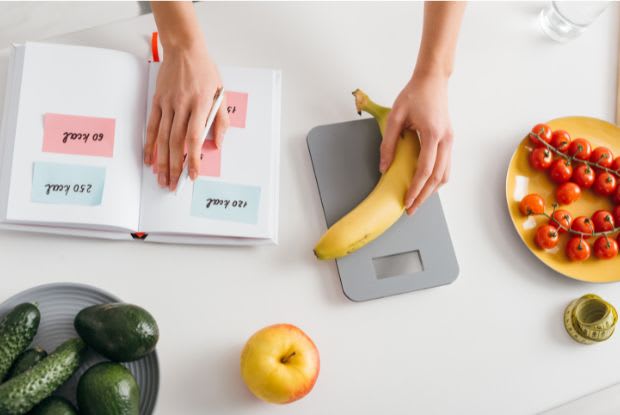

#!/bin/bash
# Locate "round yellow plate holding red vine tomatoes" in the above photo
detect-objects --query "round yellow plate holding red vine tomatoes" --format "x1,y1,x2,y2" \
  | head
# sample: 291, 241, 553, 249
506, 117, 620, 282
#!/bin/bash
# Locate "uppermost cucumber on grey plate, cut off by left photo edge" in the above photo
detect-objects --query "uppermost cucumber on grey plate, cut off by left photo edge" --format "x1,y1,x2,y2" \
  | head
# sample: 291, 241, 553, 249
0, 303, 41, 380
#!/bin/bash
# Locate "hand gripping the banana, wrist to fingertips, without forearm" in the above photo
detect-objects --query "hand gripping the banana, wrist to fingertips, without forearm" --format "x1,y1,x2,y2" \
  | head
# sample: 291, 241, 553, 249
379, 74, 452, 215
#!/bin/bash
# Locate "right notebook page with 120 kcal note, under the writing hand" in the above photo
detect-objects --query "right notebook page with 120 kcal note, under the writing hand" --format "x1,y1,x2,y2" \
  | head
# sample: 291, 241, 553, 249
140, 63, 280, 239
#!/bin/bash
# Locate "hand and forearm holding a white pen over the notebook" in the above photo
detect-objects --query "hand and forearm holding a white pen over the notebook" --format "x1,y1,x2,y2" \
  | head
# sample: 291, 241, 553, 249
144, 2, 228, 190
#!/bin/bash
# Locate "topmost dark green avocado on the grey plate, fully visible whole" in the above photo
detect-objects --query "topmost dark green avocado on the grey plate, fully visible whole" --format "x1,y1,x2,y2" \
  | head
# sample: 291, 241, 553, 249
74, 303, 159, 362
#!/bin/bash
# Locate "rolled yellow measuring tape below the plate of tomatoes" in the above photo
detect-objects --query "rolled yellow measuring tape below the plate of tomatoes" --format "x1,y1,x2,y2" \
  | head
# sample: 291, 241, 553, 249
564, 294, 618, 344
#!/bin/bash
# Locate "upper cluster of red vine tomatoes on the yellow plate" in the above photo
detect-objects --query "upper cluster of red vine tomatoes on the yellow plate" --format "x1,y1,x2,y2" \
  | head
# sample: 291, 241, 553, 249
530, 124, 620, 205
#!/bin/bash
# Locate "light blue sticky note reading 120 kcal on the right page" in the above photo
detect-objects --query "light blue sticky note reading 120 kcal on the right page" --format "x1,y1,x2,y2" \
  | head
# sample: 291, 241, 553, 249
191, 179, 260, 224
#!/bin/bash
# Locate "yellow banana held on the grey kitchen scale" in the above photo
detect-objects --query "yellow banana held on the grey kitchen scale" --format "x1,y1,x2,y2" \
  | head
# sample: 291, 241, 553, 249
314, 89, 420, 259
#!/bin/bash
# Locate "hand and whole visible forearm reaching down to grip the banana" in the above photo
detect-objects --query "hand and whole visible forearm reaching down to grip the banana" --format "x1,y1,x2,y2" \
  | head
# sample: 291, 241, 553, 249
380, 1, 465, 215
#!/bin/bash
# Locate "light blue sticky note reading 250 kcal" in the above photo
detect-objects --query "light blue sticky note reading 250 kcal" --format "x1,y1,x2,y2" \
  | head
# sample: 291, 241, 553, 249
32, 161, 105, 206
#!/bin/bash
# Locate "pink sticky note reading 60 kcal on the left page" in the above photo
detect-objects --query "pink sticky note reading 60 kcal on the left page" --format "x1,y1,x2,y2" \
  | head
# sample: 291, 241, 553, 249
43, 113, 116, 157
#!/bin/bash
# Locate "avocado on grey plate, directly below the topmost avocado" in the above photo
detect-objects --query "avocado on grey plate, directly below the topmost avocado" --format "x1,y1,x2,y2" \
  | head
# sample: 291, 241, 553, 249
77, 362, 140, 415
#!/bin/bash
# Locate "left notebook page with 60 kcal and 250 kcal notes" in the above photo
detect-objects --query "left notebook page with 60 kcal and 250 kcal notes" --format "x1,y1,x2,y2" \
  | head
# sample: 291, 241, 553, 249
6, 43, 147, 230
